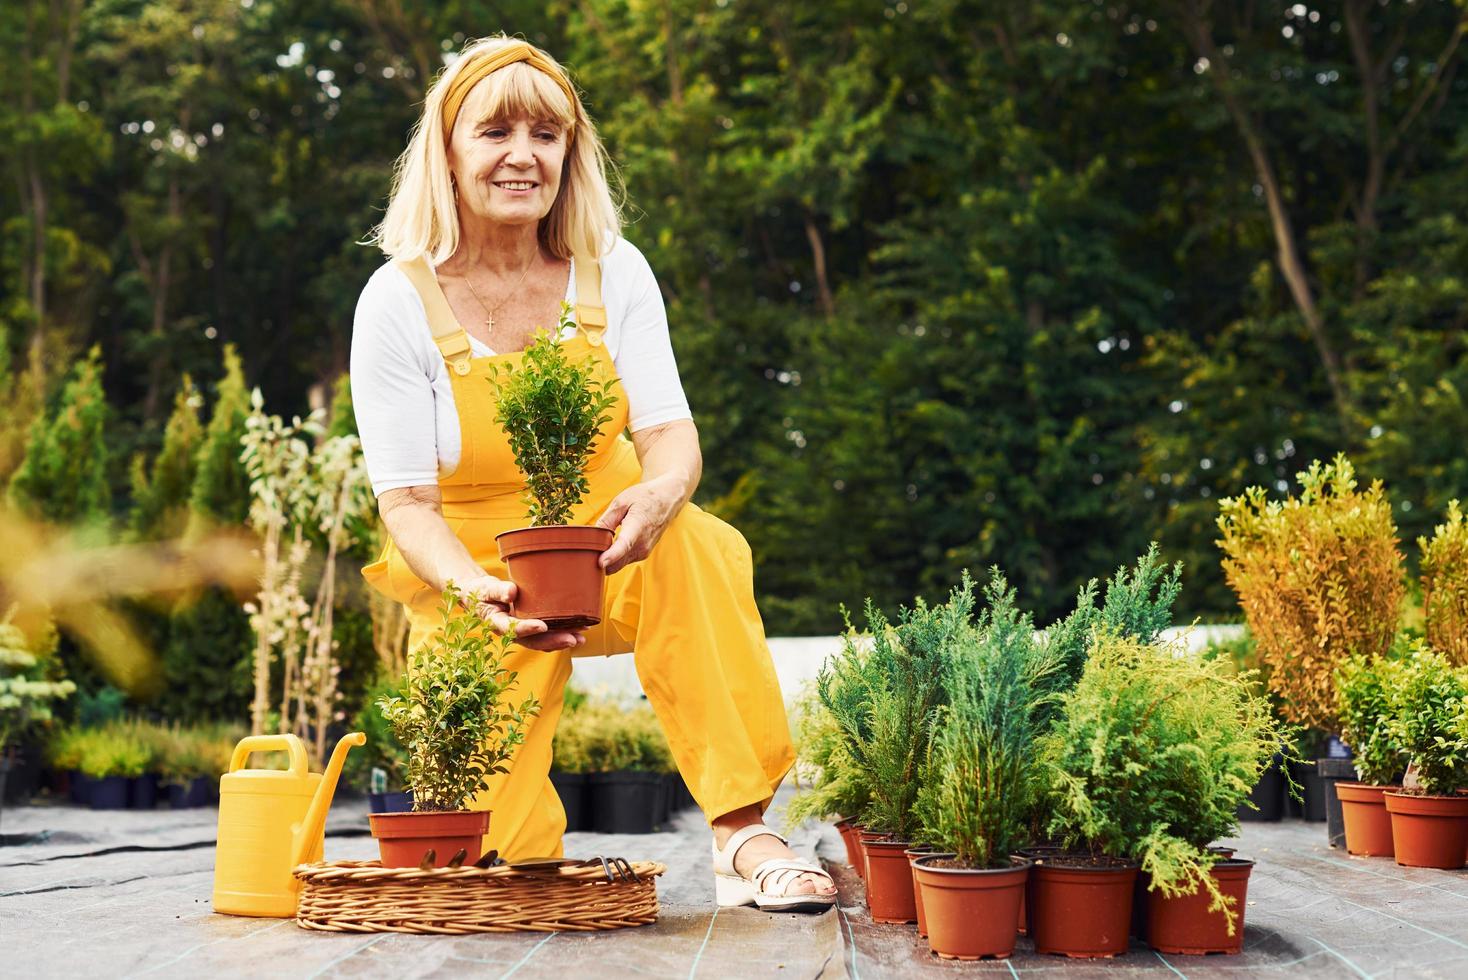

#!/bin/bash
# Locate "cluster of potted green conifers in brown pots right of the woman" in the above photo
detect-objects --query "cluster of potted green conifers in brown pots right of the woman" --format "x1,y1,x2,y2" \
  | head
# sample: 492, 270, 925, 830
790, 549, 1296, 959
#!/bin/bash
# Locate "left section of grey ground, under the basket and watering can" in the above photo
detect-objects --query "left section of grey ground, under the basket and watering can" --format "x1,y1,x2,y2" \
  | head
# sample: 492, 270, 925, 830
0, 800, 843, 980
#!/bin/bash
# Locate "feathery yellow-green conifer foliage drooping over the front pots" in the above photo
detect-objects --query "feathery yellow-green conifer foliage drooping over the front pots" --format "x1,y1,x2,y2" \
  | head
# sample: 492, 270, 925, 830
1039, 634, 1296, 930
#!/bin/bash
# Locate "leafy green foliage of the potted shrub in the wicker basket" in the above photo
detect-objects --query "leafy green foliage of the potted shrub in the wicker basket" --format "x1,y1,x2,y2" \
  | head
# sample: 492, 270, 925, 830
377, 584, 540, 811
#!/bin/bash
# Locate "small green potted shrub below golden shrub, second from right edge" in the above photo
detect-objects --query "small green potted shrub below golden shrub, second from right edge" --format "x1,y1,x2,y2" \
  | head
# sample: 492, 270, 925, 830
1336, 654, 1406, 857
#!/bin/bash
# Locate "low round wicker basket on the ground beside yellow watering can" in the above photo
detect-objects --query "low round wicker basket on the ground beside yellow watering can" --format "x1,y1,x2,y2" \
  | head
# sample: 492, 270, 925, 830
295, 861, 668, 936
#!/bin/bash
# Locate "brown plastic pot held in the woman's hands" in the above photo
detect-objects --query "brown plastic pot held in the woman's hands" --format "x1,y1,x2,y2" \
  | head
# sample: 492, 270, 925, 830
495, 524, 612, 629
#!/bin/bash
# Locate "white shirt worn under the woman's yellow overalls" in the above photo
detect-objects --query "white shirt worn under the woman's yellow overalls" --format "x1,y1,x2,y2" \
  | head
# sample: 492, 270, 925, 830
351, 238, 693, 496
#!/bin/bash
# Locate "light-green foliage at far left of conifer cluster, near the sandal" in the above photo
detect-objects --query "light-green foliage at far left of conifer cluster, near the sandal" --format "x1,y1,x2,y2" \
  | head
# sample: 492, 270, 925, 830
785, 682, 872, 827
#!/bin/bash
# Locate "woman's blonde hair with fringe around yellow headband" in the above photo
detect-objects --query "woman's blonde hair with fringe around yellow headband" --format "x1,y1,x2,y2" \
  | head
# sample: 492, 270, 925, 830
363, 34, 622, 266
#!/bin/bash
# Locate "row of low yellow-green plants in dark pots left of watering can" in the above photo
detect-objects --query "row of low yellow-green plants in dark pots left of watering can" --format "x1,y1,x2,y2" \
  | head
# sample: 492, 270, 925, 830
47, 719, 242, 810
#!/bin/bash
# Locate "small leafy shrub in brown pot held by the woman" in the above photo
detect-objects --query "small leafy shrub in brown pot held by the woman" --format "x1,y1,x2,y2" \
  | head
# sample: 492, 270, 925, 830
490, 321, 615, 629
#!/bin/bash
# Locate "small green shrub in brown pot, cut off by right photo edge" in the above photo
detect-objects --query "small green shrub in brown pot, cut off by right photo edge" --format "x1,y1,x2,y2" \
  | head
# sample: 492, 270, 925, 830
1384, 644, 1468, 869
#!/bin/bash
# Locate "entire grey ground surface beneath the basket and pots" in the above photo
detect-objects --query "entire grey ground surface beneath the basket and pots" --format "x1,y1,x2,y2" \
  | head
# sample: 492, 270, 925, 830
0, 800, 1468, 980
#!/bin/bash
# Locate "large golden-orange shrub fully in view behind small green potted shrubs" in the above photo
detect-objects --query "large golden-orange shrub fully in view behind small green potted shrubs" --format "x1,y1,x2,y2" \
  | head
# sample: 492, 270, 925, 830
1217, 455, 1405, 731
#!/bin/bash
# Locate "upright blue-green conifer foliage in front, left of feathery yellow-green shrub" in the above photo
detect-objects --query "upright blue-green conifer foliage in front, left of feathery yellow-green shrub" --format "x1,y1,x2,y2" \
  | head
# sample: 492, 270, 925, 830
916, 572, 1061, 869
